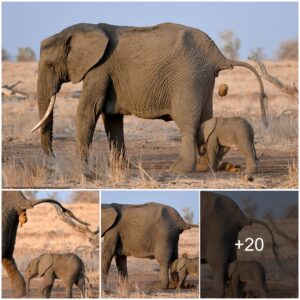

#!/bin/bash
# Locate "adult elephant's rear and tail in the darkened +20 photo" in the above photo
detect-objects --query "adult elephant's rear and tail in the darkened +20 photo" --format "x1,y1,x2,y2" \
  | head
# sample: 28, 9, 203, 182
201, 192, 280, 298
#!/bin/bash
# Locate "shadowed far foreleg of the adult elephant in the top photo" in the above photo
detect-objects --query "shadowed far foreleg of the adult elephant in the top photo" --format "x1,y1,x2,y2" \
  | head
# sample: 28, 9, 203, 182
102, 113, 125, 166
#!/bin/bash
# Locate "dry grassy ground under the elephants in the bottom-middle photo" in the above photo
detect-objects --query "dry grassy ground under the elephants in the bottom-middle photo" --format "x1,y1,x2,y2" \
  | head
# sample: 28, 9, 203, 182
102, 228, 199, 298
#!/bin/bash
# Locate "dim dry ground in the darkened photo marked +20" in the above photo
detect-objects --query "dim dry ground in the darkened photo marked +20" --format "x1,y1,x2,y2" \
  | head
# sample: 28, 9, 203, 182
201, 219, 298, 298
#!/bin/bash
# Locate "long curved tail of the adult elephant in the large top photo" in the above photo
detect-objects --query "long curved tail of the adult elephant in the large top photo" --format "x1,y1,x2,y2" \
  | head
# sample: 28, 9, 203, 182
219, 59, 268, 127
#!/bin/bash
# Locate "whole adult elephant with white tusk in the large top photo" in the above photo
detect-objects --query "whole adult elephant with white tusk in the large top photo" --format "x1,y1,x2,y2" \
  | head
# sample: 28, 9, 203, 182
32, 23, 267, 175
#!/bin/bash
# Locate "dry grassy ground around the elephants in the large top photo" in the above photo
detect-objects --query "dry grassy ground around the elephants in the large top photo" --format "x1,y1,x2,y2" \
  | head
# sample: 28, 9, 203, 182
2, 62, 298, 189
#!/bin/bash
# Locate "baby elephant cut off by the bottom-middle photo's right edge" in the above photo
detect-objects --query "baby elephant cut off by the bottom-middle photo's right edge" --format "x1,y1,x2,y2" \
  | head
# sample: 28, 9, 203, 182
171, 254, 199, 290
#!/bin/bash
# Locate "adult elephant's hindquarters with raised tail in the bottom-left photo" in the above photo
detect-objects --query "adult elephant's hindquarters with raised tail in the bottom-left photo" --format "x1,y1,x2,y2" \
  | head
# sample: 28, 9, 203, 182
2, 191, 87, 298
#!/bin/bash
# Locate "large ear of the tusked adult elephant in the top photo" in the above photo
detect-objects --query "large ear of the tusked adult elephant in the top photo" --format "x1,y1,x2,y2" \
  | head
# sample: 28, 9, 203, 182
67, 29, 109, 83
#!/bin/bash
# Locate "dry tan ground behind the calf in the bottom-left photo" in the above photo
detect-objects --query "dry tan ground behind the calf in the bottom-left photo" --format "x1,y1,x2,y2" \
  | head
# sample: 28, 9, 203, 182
2, 199, 99, 298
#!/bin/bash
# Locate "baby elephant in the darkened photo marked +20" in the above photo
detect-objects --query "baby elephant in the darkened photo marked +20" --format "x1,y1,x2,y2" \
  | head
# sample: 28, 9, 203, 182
225, 260, 268, 298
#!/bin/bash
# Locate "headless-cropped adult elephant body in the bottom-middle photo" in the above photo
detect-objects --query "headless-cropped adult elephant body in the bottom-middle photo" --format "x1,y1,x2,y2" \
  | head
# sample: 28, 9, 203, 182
101, 202, 193, 288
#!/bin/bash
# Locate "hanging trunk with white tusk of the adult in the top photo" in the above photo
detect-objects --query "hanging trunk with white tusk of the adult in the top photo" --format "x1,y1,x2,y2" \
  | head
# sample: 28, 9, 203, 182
32, 77, 56, 157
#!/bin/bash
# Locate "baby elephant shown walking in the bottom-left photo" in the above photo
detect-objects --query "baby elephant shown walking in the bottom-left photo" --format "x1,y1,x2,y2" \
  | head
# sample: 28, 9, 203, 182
25, 253, 85, 298
